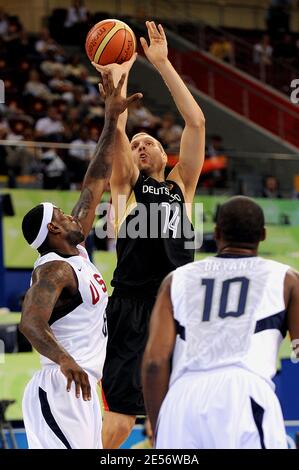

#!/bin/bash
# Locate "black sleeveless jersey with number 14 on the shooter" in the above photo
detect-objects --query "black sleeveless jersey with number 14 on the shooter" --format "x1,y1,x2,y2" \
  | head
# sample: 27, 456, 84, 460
111, 173, 194, 296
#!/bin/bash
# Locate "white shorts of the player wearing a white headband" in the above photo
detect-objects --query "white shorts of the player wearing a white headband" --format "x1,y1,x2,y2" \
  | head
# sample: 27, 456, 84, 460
22, 366, 102, 449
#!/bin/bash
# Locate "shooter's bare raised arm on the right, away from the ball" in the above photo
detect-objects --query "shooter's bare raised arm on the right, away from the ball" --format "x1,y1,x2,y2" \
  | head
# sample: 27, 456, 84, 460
140, 21, 205, 202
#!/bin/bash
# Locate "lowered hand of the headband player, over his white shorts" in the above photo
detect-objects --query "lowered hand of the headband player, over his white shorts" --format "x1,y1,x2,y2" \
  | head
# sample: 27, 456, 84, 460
60, 357, 91, 401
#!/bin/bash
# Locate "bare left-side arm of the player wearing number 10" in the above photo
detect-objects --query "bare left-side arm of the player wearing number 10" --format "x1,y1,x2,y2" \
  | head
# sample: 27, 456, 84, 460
142, 275, 176, 432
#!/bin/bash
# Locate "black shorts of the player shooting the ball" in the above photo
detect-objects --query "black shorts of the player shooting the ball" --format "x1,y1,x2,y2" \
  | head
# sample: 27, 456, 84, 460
102, 295, 155, 415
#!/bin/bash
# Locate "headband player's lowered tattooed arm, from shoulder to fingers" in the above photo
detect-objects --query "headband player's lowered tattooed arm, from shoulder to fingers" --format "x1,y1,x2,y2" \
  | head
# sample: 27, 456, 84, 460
19, 261, 91, 400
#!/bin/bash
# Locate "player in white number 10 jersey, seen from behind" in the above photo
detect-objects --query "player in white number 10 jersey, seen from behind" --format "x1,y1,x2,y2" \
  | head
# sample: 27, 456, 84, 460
142, 196, 299, 449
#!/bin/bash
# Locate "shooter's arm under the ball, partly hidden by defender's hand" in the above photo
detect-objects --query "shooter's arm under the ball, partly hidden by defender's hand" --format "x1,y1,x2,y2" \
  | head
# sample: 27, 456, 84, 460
92, 53, 139, 194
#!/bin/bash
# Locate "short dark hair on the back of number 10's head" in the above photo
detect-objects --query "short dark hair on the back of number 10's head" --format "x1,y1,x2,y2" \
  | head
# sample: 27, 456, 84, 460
217, 196, 265, 245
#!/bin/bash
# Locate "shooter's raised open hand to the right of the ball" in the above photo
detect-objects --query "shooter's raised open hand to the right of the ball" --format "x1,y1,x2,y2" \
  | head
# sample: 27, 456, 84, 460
140, 21, 168, 67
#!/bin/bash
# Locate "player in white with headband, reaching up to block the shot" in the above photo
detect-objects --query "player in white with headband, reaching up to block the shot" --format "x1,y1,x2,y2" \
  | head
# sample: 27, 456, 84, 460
20, 72, 142, 449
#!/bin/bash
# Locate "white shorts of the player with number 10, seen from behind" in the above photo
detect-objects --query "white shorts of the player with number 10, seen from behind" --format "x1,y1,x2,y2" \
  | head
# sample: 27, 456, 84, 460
156, 367, 287, 449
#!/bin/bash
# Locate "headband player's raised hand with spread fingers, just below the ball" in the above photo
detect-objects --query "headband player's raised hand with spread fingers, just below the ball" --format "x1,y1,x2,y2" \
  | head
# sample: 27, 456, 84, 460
99, 70, 142, 118
